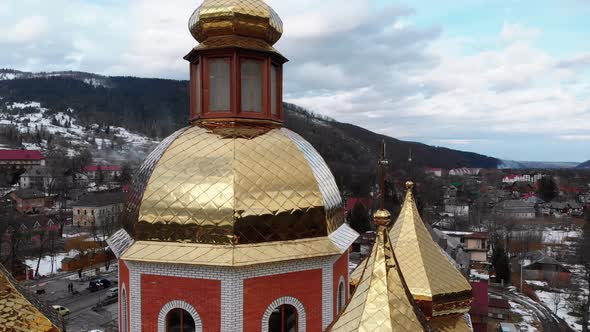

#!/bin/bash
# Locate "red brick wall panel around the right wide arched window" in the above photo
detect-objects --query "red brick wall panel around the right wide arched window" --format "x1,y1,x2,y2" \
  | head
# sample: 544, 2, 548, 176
244, 269, 322, 331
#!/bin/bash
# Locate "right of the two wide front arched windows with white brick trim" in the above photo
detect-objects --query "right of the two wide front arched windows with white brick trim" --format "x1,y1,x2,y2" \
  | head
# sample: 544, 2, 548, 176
261, 296, 306, 332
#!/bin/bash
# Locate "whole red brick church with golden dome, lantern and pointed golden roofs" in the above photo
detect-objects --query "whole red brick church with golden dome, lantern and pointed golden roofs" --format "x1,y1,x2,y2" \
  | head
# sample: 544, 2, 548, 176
99, 0, 472, 332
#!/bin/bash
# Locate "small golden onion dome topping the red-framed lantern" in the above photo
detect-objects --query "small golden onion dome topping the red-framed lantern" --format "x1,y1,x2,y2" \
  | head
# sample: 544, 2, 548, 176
189, 0, 283, 46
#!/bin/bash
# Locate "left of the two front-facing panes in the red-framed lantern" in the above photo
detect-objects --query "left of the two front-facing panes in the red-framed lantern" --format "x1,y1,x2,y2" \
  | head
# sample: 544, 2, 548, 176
209, 58, 231, 112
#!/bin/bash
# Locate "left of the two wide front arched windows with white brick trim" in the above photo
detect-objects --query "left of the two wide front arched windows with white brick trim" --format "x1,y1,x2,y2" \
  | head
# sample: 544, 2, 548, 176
158, 301, 203, 332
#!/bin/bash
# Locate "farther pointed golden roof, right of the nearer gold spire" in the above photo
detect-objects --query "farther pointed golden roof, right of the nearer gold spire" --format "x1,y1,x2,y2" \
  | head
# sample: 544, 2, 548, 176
389, 182, 471, 316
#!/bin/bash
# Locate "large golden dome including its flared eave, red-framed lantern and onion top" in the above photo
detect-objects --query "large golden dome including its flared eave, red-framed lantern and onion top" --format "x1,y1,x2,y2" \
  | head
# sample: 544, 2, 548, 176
120, 0, 356, 265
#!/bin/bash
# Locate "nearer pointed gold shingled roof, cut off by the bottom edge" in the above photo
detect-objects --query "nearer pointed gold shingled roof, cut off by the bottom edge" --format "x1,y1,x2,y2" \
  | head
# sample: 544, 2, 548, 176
328, 223, 429, 332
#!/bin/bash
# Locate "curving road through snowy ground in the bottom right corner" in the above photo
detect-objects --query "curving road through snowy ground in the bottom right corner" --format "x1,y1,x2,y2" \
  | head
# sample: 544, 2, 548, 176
489, 287, 573, 332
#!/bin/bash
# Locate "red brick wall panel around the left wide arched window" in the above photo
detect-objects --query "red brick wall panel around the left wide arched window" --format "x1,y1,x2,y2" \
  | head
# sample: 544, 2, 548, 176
141, 274, 221, 332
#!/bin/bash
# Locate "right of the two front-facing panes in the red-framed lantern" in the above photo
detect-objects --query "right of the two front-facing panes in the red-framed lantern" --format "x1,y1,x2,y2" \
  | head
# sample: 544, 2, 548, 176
241, 59, 264, 113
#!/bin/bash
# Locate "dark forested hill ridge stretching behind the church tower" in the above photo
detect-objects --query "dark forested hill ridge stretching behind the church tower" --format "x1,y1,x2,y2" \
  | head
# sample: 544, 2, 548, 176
0, 70, 498, 187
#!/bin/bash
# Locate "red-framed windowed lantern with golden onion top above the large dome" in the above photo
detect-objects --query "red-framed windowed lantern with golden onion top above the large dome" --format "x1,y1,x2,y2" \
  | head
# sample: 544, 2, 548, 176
185, 0, 287, 123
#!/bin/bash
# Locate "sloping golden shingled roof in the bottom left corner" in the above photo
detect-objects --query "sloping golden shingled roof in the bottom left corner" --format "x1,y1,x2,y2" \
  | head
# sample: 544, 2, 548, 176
0, 265, 61, 332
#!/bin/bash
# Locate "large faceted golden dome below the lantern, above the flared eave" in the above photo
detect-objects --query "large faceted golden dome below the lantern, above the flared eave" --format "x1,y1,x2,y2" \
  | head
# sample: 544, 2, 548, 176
127, 122, 343, 244
